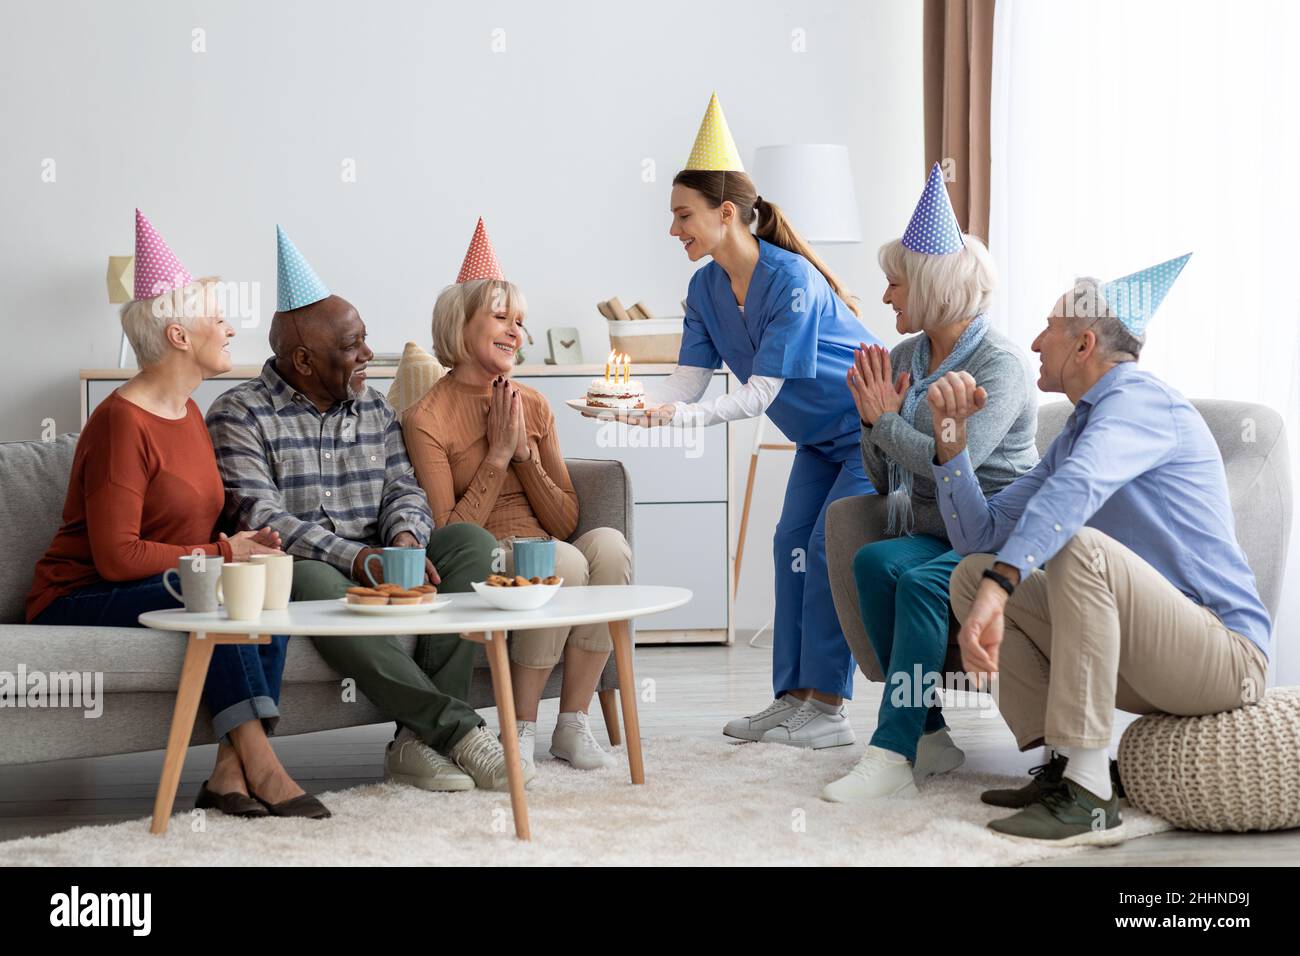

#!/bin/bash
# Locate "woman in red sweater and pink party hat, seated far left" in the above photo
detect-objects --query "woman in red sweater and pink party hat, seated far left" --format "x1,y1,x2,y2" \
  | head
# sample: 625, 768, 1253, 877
27, 211, 329, 818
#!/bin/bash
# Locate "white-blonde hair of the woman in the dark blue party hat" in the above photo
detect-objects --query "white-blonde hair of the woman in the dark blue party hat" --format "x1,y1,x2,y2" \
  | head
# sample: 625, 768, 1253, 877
879, 235, 997, 332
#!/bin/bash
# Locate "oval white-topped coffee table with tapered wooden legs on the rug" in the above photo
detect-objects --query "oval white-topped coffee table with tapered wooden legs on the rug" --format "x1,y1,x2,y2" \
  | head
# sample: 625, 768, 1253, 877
140, 584, 692, 840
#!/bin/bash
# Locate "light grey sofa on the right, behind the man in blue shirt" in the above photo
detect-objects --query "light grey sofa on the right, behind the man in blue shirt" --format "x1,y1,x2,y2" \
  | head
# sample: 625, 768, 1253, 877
826, 401, 1292, 680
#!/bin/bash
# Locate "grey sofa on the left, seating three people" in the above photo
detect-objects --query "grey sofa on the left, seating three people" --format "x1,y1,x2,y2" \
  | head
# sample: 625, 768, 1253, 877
0, 434, 632, 765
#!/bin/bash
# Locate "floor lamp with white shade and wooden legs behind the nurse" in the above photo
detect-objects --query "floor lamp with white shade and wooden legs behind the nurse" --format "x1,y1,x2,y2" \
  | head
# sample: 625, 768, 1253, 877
732, 143, 862, 646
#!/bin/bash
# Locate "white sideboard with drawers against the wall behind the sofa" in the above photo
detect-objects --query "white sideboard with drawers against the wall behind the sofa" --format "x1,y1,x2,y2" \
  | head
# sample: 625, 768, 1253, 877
81, 365, 736, 644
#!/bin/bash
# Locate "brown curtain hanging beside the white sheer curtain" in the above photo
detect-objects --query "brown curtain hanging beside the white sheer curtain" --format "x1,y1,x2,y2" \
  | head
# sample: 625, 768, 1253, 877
923, 0, 995, 242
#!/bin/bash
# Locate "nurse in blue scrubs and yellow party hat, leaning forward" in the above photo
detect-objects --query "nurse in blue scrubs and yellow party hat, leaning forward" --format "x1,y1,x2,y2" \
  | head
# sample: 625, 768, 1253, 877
647, 95, 879, 748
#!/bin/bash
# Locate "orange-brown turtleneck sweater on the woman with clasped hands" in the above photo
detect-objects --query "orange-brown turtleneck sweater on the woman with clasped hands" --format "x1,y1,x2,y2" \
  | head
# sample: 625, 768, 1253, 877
402, 375, 577, 540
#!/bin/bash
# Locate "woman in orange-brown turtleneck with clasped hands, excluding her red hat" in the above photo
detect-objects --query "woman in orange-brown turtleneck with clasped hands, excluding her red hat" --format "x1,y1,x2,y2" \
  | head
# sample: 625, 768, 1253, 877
402, 278, 632, 779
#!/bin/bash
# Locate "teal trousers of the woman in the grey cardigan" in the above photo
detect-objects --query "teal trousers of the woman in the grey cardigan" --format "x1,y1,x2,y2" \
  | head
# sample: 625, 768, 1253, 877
853, 535, 961, 763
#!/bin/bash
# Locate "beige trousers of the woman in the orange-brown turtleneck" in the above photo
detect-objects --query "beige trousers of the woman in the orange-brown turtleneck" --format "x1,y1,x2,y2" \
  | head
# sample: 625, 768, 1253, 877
497, 528, 632, 669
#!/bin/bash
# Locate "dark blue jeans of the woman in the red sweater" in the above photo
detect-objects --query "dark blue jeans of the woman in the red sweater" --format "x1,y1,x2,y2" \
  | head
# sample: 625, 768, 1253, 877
31, 575, 289, 744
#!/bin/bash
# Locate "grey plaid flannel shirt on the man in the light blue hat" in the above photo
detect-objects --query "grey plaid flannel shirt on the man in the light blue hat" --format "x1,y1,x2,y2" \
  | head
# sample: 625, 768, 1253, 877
207, 359, 433, 576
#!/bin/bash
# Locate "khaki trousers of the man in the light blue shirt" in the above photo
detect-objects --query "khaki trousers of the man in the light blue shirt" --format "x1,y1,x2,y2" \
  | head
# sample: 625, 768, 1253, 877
949, 528, 1268, 750
